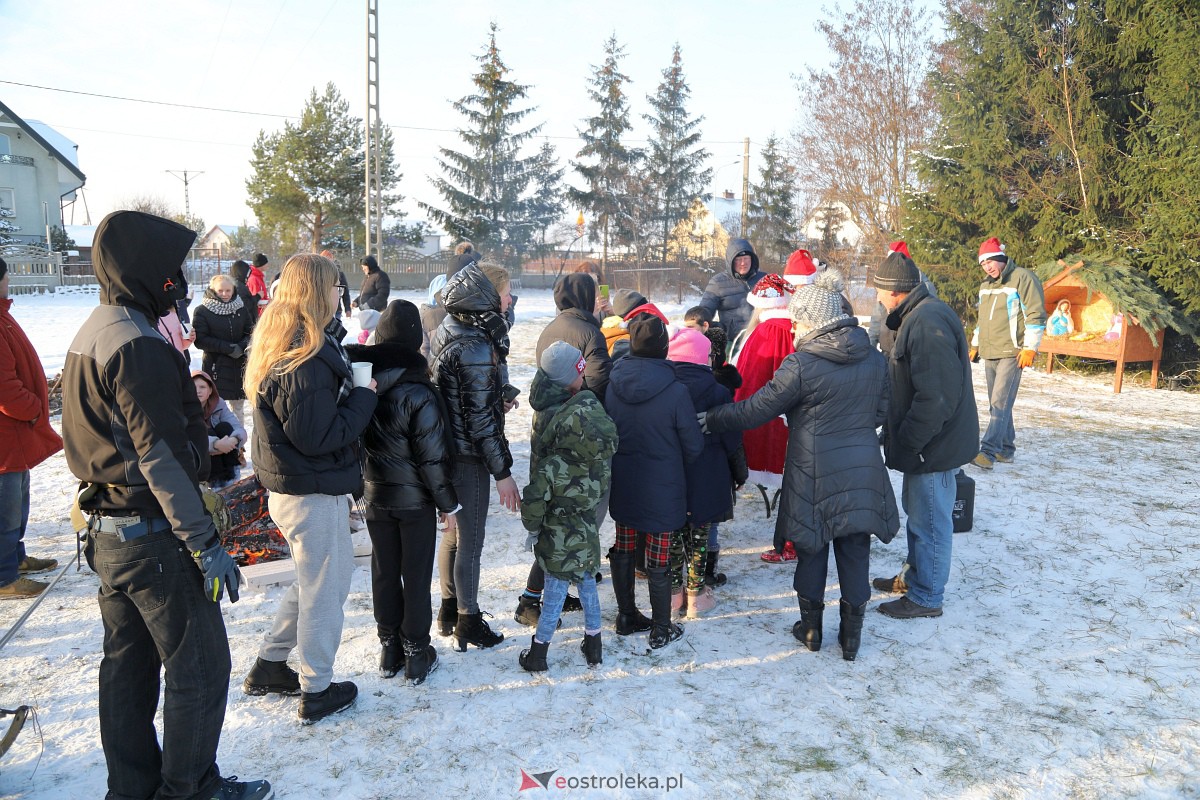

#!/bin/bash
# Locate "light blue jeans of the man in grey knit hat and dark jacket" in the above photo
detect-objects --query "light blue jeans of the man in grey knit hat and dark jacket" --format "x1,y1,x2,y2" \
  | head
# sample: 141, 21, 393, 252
901, 469, 958, 608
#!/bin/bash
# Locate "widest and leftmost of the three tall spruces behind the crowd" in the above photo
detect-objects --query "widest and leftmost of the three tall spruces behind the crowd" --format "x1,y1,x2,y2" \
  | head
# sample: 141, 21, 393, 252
418, 23, 541, 260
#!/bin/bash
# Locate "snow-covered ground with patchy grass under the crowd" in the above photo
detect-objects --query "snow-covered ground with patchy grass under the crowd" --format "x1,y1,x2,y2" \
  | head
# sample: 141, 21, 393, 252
0, 286, 1200, 800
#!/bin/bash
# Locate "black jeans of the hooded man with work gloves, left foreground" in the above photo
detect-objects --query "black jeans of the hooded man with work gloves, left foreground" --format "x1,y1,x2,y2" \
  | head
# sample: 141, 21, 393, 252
84, 530, 229, 800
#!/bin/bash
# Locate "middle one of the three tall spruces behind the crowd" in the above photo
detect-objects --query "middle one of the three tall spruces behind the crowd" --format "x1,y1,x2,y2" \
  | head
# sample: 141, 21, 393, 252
568, 34, 641, 259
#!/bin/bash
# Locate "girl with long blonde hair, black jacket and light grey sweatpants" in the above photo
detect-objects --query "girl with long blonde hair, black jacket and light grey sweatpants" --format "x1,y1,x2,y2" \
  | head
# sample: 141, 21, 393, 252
244, 253, 376, 724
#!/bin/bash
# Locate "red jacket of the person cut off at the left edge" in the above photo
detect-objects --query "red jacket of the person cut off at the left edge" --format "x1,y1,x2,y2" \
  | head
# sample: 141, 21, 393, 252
0, 297, 62, 473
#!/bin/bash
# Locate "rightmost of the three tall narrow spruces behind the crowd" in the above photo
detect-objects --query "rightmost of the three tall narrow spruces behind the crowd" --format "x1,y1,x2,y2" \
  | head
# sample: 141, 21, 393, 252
642, 42, 713, 260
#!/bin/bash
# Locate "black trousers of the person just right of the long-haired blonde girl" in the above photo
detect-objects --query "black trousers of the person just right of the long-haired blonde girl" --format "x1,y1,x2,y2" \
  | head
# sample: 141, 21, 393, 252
367, 506, 437, 646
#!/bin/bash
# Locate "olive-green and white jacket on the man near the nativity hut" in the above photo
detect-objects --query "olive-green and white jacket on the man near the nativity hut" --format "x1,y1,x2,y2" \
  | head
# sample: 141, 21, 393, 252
971, 259, 1046, 359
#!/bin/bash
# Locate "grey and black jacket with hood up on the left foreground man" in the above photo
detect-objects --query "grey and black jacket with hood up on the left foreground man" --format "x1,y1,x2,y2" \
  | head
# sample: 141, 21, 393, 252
62, 211, 216, 551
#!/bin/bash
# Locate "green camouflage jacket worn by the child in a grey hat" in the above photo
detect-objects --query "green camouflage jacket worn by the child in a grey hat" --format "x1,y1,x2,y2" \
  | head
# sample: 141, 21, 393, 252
521, 383, 617, 582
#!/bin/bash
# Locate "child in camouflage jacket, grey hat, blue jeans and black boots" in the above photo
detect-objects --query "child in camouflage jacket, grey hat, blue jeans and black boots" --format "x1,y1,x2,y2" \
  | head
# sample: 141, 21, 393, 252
520, 342, 617, 672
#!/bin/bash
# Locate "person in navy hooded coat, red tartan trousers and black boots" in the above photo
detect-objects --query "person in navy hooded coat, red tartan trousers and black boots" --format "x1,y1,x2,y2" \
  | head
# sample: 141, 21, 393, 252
605, 314, 704, 649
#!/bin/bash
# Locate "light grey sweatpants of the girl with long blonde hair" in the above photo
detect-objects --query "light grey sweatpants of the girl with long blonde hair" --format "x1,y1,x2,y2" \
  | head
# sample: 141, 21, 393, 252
258, 492, 354, 692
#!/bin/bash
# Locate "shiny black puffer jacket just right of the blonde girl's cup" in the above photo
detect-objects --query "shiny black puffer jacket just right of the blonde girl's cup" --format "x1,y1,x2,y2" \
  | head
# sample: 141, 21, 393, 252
346, 342, 458, 512
